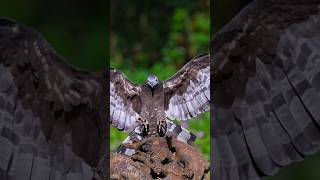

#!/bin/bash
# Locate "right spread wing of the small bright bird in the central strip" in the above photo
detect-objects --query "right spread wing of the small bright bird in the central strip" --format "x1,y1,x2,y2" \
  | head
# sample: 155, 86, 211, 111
163, 55, 210, 120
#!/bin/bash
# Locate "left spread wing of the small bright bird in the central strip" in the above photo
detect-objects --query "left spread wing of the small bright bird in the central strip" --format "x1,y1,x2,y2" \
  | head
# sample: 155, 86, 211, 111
110, 69, 141, 131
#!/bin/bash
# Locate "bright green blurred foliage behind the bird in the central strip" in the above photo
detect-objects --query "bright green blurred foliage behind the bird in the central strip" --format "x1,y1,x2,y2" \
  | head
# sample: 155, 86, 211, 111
110, 0, 210, 159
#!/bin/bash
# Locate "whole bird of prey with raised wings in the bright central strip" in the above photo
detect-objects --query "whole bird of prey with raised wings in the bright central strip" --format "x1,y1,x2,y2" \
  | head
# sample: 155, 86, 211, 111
110, 55, 210, 154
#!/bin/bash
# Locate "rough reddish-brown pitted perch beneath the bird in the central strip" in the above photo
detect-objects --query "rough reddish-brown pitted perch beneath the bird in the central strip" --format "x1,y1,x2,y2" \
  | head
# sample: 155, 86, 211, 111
110, 137, 209, 180
